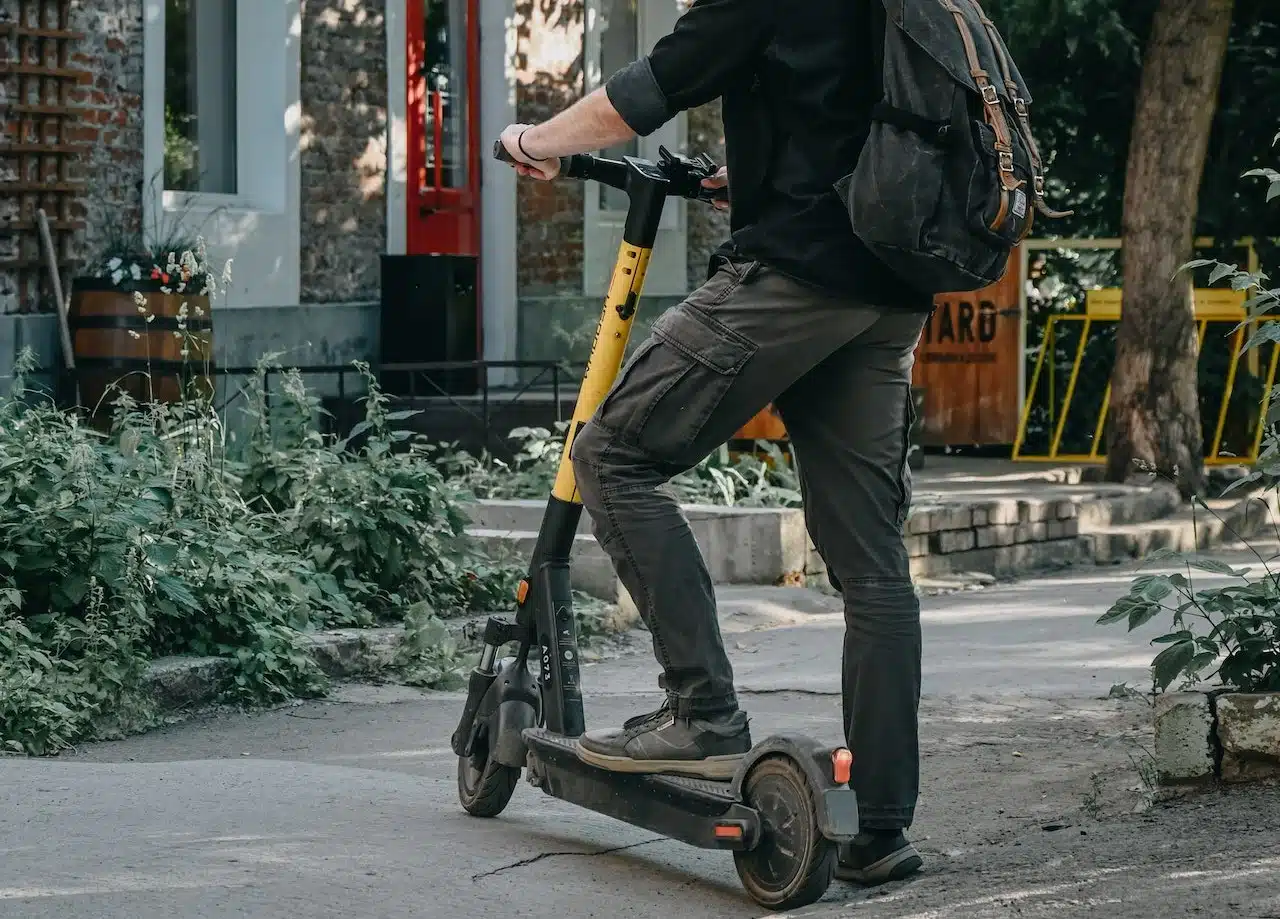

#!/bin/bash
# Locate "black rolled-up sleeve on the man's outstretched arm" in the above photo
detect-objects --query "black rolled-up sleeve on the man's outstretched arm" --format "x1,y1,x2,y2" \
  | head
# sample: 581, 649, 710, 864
604, 0, 774, 137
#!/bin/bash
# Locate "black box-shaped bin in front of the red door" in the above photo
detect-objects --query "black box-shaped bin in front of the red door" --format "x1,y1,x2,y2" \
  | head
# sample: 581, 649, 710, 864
380, 255, 481, 397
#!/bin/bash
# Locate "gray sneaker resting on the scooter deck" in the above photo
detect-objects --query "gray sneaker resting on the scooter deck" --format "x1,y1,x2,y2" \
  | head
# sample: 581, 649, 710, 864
577, 705, 751, 781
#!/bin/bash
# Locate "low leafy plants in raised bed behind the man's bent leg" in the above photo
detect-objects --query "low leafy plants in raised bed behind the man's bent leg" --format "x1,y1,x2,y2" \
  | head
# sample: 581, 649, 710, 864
438, 422, 801, 507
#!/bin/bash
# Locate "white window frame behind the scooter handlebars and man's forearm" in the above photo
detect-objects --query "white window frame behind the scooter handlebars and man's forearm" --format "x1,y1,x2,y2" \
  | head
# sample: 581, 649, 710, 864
582, 0, 687, 294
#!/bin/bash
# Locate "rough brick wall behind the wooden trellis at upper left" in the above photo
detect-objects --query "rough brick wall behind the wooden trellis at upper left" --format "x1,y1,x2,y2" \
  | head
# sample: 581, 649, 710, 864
0, 0, 142, 312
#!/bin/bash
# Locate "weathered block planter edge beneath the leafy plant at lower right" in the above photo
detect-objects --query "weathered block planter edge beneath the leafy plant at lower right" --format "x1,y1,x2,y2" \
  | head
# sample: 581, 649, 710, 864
1156, 689, 1280, 796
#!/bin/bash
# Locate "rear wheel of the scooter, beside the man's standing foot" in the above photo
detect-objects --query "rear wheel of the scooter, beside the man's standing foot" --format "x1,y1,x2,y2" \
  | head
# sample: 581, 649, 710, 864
733, 756, 836, 910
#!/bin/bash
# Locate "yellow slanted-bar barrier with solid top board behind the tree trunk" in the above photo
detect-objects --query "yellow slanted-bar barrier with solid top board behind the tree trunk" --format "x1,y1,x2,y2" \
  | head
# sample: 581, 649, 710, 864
1012, 288, 1280, 466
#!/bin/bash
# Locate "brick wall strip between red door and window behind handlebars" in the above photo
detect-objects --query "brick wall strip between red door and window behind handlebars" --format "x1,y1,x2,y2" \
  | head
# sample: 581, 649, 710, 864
515, 0, 585, 296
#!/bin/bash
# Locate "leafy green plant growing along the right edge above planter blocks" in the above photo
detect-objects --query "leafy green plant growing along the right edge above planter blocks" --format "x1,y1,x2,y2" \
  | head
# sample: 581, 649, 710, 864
1098, 143, 1280, 692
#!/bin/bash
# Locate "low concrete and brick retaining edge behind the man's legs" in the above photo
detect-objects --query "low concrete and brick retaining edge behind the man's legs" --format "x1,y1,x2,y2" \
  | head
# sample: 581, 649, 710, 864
470, 483, 1276, 596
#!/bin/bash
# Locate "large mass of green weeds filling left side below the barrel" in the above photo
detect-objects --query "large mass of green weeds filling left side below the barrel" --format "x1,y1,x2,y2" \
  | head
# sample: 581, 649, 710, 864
0, 247, 518, 755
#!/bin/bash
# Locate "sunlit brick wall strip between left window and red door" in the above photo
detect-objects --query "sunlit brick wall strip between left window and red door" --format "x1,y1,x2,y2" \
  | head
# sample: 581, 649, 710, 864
301, 0, 387, 303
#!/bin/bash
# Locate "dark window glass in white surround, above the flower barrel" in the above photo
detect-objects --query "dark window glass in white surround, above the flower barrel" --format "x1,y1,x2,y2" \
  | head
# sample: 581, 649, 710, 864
164, 0, 238, 195
